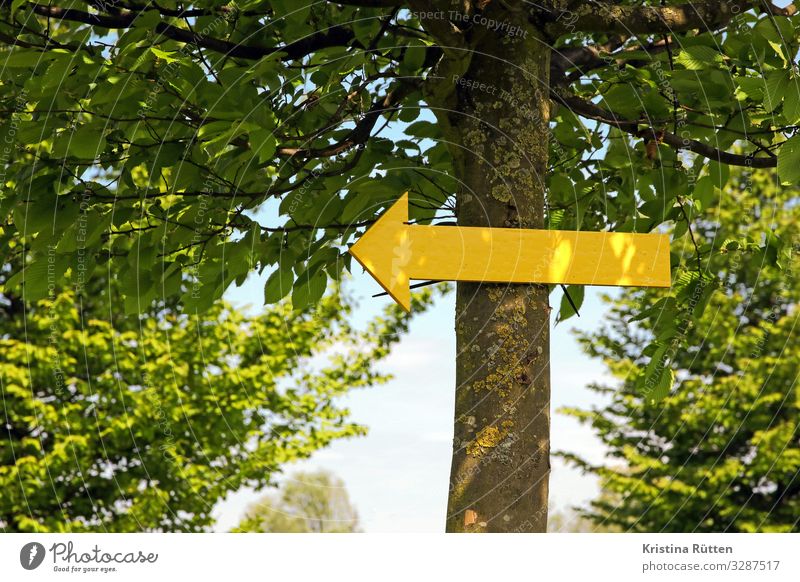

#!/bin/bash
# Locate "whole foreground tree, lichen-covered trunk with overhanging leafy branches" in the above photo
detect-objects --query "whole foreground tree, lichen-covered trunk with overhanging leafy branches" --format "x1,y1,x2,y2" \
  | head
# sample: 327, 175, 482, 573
0, 0, 800, 531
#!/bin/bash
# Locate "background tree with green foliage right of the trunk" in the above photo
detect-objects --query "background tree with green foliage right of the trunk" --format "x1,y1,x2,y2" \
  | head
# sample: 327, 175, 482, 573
567, 171, 800, 532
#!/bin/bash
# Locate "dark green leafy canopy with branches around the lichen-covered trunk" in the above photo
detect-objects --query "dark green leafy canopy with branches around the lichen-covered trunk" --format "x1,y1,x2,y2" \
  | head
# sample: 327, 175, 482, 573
0, 0, 800, 402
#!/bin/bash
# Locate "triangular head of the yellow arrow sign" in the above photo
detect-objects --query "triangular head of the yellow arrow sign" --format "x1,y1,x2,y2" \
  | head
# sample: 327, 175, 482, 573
350, 192, 411, 311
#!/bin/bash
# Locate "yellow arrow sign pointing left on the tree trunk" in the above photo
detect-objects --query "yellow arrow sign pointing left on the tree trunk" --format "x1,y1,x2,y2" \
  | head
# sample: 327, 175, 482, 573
350, 193, 670, 311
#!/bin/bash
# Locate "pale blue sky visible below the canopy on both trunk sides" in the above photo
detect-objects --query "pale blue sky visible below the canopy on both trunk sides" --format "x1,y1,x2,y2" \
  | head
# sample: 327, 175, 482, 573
215, 269, 620, 532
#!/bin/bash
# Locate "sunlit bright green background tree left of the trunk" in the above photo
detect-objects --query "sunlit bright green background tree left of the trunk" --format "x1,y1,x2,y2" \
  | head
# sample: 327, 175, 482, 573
0, 260, 424, 532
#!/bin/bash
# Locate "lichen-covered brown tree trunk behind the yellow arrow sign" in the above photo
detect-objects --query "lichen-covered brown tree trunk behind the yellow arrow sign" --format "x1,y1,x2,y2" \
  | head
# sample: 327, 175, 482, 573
438, 13, 550, 532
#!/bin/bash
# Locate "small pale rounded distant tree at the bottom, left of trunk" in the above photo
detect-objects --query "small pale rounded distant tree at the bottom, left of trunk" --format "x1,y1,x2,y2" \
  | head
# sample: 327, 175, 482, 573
234, 470, 360, 533
